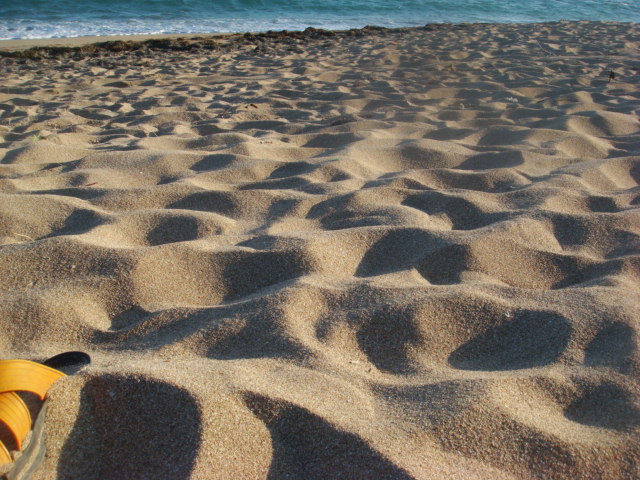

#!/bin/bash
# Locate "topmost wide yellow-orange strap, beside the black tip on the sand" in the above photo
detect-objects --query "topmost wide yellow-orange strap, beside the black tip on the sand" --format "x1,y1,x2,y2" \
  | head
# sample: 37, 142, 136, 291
0, 360, 64, 400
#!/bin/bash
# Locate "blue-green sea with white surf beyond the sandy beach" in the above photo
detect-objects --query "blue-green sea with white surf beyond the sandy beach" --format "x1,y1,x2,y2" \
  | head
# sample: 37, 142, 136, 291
0, 0, 640, 39
